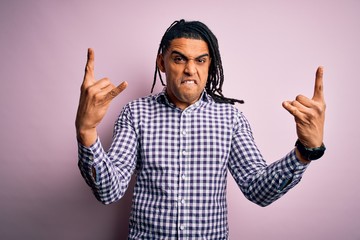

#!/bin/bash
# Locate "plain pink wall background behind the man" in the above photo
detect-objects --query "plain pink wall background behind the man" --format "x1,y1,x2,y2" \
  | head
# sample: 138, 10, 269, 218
0, 0, 360, 240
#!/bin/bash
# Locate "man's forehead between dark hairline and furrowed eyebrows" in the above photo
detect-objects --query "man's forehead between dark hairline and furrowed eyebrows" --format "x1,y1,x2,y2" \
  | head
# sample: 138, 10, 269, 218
167, 38, 209, 57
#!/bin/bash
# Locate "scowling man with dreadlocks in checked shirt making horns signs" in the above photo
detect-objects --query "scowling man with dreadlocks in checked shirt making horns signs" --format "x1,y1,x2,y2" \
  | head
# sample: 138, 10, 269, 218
76, 20, 325, 240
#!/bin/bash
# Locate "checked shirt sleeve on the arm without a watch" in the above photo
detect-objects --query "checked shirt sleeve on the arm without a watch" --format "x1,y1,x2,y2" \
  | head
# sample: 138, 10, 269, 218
78, 107, 137, 204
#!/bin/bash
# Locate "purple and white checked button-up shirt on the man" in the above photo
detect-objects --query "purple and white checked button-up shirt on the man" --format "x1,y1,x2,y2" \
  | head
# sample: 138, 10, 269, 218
78, 91, 307, 240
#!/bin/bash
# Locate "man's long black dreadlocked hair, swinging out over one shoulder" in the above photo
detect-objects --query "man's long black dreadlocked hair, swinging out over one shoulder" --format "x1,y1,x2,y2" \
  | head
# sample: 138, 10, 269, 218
151, 19, 244, 104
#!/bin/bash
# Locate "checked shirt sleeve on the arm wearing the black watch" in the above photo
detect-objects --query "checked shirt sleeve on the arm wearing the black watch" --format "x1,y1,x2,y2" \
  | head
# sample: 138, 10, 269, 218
228, 110, 308, 206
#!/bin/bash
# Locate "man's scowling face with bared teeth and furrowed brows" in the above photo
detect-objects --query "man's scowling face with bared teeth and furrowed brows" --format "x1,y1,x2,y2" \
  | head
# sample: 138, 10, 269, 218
157, 38, 211, 109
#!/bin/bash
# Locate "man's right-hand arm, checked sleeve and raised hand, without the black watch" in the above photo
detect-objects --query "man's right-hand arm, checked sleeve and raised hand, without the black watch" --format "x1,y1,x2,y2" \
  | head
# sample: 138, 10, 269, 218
229, 67, 325, 206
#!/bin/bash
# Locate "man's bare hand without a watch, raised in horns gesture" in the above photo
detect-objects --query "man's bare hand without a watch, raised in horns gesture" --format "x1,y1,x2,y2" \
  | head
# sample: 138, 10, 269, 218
75, 48, 127, 147
